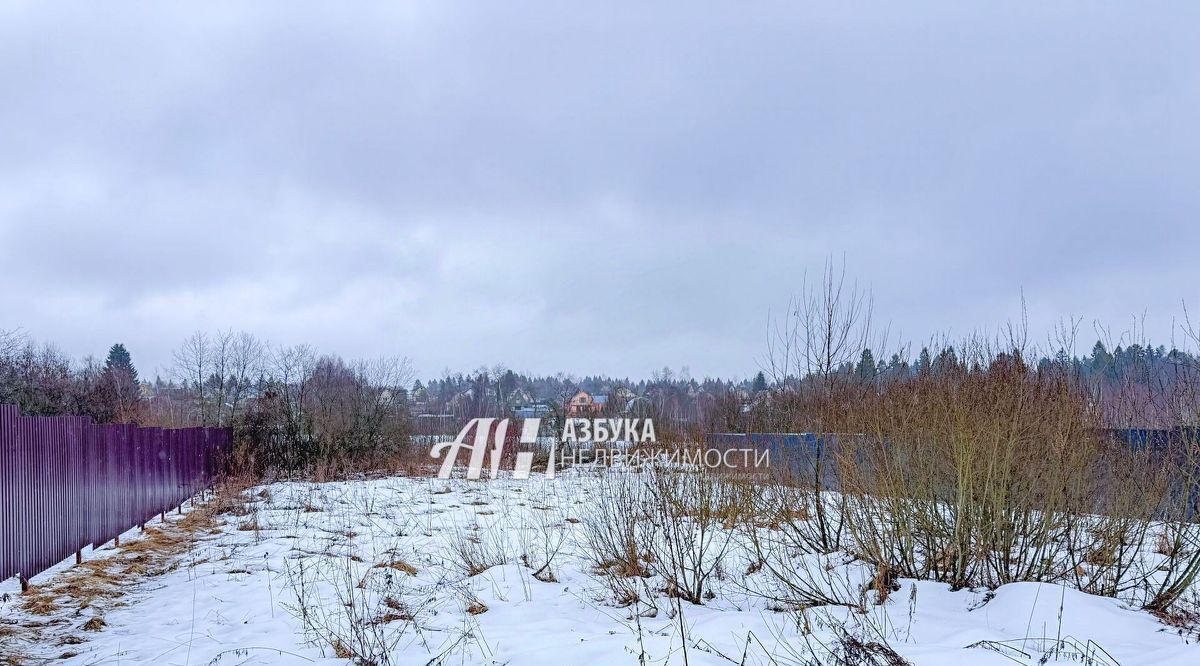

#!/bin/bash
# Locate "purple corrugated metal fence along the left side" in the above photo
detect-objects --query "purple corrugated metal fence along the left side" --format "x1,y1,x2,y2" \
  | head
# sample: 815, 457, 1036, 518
0, 404, 230, 580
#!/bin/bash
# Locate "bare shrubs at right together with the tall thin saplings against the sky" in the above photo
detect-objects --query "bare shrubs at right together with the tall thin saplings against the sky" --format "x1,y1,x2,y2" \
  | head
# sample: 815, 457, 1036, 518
748, 266, 1200, 611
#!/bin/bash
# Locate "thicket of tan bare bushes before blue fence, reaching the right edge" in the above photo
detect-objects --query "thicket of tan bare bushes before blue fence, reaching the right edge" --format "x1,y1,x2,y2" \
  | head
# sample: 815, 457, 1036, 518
753, 353, 1200, 607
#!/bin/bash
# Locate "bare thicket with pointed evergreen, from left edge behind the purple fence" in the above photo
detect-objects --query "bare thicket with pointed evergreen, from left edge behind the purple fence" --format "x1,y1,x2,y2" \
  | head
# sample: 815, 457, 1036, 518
0, 331, 413, 474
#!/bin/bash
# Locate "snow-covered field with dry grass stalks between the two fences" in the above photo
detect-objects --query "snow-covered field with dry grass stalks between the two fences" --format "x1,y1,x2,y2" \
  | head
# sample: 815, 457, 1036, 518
0, 474, 1200, 666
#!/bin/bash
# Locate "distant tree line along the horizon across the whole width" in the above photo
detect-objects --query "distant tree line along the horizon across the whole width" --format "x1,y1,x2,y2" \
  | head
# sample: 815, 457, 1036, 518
7, 331, 1200, 448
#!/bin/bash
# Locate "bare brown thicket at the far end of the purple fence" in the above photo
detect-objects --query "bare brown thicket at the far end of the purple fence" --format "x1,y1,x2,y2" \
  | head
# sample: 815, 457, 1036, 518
163, 332, 413, 474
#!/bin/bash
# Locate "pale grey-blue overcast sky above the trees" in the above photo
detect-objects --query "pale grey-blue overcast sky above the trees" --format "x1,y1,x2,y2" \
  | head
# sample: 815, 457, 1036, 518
0, 0, 1200, 377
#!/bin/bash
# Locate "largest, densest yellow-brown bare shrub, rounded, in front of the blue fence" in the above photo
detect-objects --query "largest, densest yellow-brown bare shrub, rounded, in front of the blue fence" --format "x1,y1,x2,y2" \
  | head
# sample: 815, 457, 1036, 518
834, 350, 1102, 587
